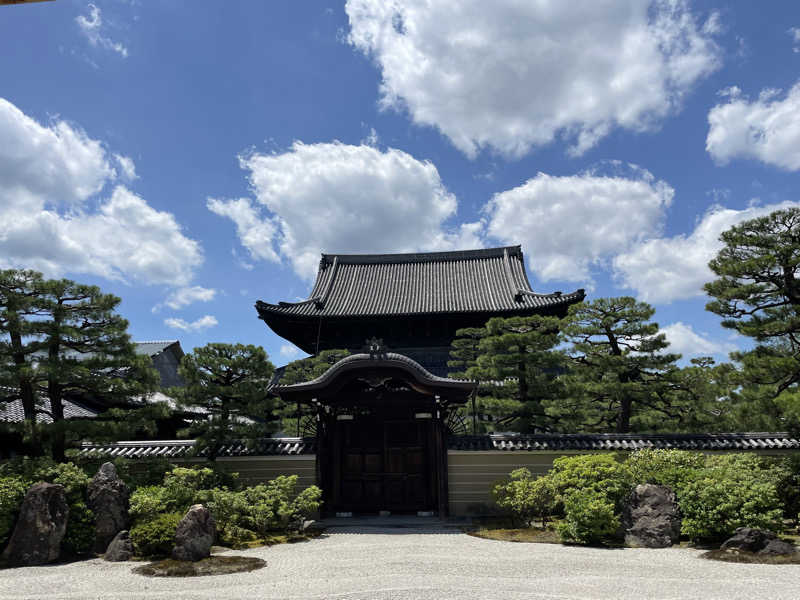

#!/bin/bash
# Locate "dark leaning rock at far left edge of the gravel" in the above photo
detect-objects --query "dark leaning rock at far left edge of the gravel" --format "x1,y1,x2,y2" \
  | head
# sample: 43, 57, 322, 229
3, 483, 69, 567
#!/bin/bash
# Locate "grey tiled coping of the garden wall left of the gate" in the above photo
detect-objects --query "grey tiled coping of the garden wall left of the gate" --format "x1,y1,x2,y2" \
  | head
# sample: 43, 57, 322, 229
80, 438, 315, 458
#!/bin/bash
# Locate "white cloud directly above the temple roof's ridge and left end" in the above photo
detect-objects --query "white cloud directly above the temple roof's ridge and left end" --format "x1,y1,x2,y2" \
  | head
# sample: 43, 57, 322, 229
208, 142, 482, 279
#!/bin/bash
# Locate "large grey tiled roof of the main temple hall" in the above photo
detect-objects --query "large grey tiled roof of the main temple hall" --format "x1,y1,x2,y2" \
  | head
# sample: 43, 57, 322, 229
256, 246, 584, 318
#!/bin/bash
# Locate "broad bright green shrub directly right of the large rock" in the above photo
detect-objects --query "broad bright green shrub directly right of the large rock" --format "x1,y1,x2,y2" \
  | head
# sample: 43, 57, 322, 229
680, 454, 784, 541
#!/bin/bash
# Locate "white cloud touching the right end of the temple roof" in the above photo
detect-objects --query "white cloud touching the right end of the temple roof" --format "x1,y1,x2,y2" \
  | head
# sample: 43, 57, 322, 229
486, 164, 674, 281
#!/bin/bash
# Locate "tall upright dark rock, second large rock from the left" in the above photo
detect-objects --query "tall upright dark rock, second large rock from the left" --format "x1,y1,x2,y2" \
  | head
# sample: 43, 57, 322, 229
89, 462, 131, 554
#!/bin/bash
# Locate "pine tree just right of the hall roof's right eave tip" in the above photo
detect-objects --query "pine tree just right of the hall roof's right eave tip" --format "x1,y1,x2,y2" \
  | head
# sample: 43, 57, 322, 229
562, 297, 680, 433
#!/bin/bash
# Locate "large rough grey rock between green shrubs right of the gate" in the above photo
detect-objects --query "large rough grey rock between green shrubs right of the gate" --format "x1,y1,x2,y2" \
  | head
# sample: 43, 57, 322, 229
622, 483, 681, 548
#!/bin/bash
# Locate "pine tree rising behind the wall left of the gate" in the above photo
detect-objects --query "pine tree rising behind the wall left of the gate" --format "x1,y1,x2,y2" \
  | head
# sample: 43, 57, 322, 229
170, 343, 276, 460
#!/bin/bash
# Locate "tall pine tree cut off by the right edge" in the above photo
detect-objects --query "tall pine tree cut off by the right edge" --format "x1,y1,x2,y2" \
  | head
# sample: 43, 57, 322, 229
705, 208, 800, 429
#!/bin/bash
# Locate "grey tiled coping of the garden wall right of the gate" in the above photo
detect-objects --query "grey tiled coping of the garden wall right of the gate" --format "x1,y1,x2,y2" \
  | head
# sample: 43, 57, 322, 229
448, 433, 800, 452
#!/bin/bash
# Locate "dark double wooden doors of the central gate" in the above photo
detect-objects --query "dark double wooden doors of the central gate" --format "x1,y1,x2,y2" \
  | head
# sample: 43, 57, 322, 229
334, 417, 435, 512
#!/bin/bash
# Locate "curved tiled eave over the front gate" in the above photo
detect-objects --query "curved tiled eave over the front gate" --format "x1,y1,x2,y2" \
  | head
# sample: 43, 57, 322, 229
272, 353, 476, 396
